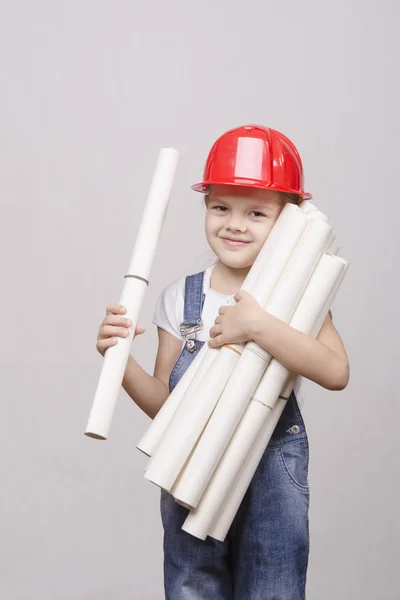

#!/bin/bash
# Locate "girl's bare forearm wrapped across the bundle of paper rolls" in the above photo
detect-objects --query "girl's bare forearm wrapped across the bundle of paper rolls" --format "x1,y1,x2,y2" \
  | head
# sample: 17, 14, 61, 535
250, 313, 347, 390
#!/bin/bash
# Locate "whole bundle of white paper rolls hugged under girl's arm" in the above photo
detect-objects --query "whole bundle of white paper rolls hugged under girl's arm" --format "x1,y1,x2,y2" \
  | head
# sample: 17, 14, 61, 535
138, 201, 347, 539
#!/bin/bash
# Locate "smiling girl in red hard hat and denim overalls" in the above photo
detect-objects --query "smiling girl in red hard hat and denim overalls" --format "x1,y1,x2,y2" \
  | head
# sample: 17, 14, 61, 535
96, 126, 349, 600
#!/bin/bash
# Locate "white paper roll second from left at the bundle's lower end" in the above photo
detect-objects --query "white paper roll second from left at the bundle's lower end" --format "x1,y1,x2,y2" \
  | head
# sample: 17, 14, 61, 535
145, 204, 310, 490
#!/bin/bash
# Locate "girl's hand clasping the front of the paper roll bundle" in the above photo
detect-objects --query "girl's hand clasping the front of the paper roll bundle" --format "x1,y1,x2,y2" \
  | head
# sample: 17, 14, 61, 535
208, 290, 266, 348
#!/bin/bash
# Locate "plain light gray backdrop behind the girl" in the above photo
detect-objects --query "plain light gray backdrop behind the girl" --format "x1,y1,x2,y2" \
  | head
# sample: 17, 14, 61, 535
0, 0, 400, 600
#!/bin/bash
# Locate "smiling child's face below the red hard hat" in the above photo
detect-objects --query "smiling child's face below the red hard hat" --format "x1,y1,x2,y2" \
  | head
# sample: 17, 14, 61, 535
206, 185, 285, 269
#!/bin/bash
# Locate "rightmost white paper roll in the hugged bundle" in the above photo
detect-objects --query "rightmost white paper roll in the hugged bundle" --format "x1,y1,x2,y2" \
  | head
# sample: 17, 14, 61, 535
203, 258, 349, 541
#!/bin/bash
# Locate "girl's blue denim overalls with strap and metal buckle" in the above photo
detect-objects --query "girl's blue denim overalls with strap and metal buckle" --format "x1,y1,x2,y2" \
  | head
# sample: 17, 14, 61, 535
160, 272, 309, 600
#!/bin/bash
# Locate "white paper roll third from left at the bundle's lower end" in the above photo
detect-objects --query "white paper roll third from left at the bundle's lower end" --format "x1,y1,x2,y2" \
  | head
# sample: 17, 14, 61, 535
171, 219, 335, 507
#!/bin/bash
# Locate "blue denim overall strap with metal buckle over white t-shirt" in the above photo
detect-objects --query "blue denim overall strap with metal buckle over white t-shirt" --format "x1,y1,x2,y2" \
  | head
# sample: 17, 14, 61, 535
180, 271, 204, 352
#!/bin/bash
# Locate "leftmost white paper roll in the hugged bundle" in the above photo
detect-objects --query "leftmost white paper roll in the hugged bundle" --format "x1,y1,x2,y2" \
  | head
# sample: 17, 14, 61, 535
137, 204, 303, 460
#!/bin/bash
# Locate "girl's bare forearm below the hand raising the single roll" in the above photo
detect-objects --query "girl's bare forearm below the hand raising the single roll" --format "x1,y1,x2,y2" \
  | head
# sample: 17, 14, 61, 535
122, 355, 169, 419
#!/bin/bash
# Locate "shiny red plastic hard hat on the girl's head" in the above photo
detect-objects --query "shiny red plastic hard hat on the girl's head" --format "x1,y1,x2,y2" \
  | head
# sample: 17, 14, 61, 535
192, 125, 312, 200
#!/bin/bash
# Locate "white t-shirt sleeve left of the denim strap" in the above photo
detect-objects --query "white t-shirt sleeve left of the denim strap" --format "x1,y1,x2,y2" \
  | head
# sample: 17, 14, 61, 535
153, 277, 185, 340
